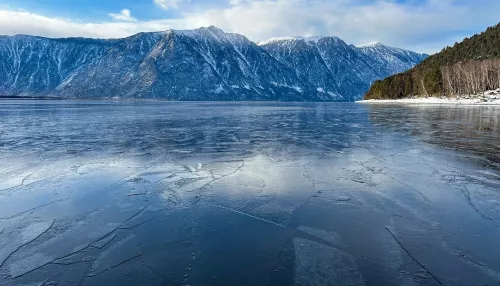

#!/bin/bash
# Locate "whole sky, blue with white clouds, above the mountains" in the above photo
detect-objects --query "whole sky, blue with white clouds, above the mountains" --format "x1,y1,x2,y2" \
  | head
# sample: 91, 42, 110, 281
0, 0, 500, 54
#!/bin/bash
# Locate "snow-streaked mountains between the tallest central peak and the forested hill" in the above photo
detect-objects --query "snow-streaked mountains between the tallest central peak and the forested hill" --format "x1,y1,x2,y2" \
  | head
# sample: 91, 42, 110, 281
259, 37, 427, 100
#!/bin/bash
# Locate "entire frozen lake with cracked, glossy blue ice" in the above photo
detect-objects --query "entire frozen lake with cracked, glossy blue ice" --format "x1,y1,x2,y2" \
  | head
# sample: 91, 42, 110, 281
0, 101, 500, 286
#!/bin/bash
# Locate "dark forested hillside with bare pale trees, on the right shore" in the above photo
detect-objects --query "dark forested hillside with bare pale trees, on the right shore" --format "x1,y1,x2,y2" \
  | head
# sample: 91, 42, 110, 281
365, 24, 500, 99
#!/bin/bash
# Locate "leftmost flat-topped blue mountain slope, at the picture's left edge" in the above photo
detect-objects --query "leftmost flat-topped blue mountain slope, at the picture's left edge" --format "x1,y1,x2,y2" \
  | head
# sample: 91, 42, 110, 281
0, 35, 112, 95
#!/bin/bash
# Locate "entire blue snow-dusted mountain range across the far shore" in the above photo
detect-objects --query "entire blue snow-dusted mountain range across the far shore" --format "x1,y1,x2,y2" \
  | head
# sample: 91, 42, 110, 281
0, 26, 427, 101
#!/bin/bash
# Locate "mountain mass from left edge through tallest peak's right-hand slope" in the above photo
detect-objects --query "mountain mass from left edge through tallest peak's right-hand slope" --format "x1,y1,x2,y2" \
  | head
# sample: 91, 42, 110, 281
0, 27, 316, 101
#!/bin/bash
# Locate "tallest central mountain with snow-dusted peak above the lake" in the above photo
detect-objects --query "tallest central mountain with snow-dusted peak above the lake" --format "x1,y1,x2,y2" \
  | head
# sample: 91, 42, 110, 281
139, 27, 319, 101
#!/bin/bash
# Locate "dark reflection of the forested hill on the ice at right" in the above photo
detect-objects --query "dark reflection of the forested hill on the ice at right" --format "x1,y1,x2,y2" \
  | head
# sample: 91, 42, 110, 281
369, 105, 500, 168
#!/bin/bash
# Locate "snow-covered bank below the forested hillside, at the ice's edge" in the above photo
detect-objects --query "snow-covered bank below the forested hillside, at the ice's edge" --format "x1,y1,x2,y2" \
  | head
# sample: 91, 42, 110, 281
356, 89, 500, 105
